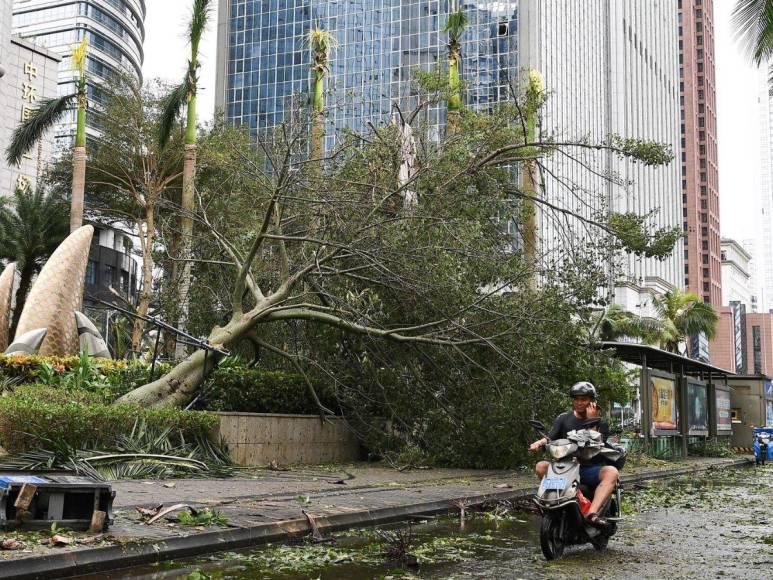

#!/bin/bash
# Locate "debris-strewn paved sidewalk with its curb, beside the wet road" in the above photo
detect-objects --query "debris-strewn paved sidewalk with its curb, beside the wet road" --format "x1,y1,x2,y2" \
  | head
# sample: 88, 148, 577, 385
0, 458, 748, 579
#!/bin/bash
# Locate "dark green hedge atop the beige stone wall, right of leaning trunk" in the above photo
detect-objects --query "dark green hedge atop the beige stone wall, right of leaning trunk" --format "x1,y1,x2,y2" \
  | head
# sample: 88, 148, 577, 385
204, 365, 337, 415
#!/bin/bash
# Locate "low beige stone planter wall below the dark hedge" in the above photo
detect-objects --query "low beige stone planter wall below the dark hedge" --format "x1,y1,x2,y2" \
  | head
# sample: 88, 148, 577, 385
216, 413, 360, 465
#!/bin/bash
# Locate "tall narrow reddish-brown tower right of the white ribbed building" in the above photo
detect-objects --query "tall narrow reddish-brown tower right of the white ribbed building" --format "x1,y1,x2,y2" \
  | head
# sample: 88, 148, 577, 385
679, 0, 728, 307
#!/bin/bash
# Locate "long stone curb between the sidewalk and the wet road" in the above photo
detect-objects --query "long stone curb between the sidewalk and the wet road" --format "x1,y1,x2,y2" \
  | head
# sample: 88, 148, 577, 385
0, 459, 752, 580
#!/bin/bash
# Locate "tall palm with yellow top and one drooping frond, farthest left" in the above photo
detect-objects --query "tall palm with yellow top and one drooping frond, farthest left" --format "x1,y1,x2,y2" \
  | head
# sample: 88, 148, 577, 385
6, 35, 87, 232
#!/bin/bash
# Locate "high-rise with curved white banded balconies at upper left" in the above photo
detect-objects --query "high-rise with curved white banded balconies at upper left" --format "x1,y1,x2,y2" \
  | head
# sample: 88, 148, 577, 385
13, 0, 145, 147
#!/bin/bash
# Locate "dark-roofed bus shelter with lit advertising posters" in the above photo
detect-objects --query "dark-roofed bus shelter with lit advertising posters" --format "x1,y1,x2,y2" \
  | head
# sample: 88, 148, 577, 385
601, 342, 733, 457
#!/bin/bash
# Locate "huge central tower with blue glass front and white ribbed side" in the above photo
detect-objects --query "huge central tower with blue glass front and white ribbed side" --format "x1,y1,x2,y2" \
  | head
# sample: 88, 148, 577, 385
216, 0, 684, 313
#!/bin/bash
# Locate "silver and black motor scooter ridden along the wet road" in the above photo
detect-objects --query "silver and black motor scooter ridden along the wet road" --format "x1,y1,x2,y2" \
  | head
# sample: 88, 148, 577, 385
529, 419, 623, 560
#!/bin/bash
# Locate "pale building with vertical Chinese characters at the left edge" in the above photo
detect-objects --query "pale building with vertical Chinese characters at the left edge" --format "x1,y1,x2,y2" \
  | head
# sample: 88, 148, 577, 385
0, 0, 61, 196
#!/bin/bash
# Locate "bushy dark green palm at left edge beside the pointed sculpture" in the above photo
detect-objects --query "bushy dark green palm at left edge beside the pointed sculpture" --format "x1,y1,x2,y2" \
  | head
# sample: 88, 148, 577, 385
0, 188, 68, 336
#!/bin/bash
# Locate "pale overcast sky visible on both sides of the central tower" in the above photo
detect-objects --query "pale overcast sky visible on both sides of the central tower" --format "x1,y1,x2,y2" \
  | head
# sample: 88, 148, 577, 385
144, 0, 760, 240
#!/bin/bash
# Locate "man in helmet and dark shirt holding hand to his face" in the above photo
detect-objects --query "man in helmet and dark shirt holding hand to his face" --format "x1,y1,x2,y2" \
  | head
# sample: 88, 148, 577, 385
529, 381, 619, 528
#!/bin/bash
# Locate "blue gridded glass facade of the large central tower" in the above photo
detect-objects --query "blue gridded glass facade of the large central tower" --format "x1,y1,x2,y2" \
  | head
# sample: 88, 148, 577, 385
219, 0, 518, 144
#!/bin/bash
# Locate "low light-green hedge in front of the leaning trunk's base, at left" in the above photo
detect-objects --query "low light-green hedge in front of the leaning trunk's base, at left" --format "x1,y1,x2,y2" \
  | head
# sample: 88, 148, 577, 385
0, 385, 219, 453
